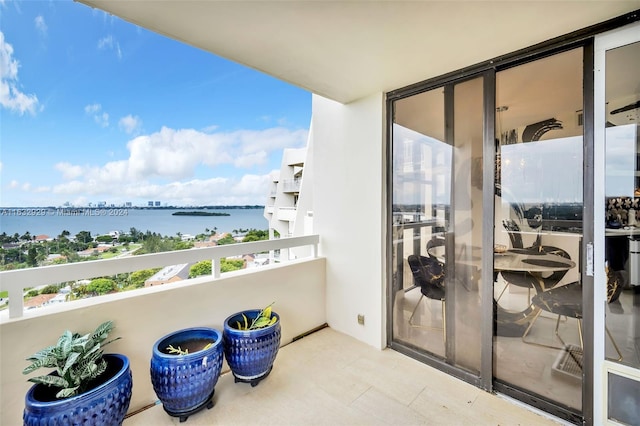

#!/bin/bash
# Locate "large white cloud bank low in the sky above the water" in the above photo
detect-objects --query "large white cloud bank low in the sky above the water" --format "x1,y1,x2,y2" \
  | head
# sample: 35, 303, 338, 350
13, 125, 307, 205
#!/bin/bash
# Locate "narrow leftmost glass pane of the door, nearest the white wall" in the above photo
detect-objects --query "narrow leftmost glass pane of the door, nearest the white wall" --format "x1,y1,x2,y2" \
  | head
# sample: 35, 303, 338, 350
392, 88, 452, 358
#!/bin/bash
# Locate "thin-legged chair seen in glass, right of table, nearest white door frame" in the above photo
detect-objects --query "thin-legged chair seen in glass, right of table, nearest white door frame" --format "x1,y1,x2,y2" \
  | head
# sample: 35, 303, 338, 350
522, 281, 622, 361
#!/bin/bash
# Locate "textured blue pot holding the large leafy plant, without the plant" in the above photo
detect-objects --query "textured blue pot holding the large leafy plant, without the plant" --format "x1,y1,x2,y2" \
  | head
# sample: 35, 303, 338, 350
22, 354, 133, 426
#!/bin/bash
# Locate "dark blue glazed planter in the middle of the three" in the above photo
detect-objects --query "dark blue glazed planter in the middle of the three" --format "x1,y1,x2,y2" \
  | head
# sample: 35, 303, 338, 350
151, 327, 223, 422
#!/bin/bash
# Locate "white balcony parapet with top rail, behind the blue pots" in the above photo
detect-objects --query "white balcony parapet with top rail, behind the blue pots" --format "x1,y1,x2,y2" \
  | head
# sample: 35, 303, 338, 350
0, 235, 327, 425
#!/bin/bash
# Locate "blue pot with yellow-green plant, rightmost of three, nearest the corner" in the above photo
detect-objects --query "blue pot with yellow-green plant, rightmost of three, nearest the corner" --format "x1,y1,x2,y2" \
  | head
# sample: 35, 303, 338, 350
222, 303, 281, 386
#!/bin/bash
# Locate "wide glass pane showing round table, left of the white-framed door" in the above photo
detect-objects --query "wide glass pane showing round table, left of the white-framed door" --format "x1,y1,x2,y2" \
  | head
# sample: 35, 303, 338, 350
494, 49, 583, 412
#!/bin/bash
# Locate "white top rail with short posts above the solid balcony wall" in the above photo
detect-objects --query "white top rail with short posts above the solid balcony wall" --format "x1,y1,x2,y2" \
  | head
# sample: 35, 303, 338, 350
0, 235, 319, 318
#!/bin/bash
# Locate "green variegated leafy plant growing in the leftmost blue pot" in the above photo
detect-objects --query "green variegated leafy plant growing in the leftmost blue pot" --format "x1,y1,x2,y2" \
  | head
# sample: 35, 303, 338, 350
22, 321, 120, 398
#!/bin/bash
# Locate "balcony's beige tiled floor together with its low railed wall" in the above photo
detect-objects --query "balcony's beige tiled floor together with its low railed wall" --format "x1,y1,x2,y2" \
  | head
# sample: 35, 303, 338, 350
0, 235, 555, 426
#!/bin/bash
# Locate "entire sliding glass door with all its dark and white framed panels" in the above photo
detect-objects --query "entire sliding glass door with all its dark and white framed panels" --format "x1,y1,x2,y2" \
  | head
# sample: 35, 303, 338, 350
387, 16, 640, 424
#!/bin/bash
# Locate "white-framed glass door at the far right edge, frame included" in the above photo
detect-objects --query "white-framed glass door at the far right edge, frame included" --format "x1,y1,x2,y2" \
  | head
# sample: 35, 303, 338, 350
594, 25, 640, 424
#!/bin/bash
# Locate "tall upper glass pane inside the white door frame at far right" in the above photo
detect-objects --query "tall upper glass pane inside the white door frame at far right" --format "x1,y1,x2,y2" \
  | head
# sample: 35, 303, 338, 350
601, 42, 640, 368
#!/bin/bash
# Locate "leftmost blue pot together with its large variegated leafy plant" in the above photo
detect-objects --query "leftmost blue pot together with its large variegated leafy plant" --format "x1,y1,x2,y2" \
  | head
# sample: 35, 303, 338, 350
22, 321, 133, 426
